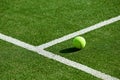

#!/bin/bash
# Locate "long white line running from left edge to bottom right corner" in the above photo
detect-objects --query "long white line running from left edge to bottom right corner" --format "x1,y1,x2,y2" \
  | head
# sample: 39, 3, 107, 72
0, 33, 119, 80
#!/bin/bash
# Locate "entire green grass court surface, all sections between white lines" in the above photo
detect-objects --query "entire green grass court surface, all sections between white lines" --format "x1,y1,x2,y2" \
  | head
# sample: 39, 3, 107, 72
0, 0, 120, 80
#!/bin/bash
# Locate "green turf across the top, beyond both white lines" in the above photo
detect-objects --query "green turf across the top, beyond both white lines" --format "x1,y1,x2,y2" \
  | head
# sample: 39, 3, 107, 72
0, 0, 120, 45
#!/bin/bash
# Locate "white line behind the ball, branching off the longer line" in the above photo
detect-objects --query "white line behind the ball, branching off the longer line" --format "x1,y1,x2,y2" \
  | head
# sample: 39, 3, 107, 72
37, 16, 120, 49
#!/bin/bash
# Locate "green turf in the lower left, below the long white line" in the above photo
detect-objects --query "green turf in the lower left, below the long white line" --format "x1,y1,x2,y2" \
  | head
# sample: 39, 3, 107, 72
0, 40, 100, 80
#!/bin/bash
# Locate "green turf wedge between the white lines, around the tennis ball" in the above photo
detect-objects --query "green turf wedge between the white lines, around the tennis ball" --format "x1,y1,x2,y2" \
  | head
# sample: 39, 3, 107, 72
46, 21, 120, 78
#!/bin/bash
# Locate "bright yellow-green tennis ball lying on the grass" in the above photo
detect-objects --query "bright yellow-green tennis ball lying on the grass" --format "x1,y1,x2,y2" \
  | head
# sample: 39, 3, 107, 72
73, 36, 86, 49
